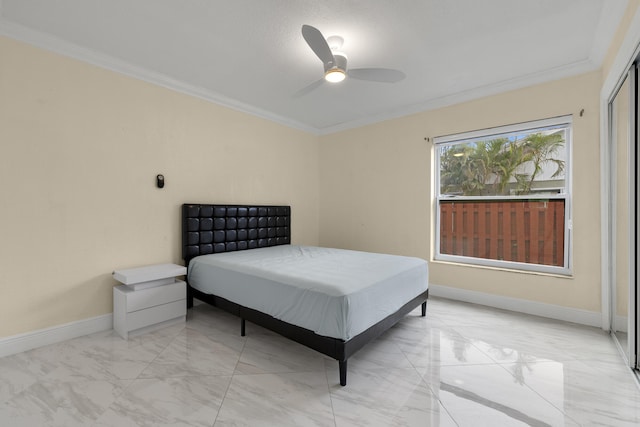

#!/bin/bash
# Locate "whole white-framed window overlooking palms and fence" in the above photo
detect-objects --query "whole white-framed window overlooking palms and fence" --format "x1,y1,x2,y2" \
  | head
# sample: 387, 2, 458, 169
434, 116, 571, 274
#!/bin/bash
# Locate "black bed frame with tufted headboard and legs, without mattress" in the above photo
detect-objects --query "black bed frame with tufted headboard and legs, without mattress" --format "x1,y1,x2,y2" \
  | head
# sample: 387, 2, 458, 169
182, 203, 429, 386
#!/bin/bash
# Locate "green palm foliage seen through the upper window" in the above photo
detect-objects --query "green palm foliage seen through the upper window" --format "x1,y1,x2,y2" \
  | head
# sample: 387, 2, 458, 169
440, 133, 565, 196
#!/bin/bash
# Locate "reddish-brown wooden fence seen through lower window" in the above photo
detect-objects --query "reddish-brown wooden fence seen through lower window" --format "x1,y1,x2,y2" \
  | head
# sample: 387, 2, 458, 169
440, 199, 565, 267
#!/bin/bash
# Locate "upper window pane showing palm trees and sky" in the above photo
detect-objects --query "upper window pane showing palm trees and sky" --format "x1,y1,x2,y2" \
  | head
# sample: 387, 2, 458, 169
437, 124, 568, 197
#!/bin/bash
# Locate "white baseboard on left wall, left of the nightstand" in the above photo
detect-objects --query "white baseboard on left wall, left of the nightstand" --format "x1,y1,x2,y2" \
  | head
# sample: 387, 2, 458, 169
0, 313, 113, 357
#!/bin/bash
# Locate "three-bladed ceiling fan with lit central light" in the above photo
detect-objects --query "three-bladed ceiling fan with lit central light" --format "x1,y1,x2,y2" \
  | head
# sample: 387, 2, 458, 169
296, 25, 405, 96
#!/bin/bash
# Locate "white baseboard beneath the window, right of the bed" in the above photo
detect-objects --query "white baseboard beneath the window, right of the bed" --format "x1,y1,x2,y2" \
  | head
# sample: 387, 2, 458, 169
429, 284, 602, 328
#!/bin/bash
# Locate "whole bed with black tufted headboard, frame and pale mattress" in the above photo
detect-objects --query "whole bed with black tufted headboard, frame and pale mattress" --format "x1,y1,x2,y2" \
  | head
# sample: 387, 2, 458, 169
182, 203, 429, 386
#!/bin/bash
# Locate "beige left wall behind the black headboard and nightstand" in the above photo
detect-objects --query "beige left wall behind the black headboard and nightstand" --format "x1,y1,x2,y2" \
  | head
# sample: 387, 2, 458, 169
0, 37, 318, 337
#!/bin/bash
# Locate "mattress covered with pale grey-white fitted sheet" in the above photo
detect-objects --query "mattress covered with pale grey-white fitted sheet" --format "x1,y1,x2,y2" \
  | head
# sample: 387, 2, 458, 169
188, 245, 428, 341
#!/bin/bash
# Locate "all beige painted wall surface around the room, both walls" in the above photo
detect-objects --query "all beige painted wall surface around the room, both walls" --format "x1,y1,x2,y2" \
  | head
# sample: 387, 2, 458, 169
0, 5, 640, 337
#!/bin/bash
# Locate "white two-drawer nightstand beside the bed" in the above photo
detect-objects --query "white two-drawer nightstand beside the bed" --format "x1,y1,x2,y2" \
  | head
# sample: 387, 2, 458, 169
113, 264, 187, 339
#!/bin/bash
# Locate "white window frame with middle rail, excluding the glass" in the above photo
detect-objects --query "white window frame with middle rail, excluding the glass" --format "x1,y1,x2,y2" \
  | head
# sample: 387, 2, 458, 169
433, 115, 573, 275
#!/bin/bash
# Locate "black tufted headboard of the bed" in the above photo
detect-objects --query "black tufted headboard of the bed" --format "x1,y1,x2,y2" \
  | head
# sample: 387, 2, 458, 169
182, 203, 291, 265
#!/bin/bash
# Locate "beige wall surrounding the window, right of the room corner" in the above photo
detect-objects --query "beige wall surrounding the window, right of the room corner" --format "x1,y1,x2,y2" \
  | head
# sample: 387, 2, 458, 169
320, 72, 601, 311
